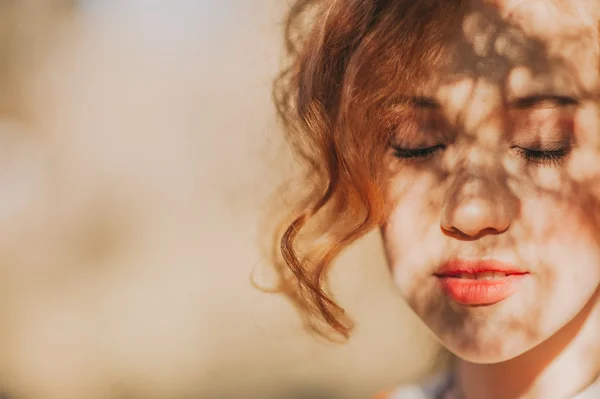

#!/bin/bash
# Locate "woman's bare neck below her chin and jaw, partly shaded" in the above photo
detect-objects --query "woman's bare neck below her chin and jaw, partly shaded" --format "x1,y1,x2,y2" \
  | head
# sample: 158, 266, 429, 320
456, 290, 600, 399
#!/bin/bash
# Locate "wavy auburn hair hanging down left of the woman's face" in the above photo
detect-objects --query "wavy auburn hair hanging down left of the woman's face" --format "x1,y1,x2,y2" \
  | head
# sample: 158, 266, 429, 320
274, 0, 464, 336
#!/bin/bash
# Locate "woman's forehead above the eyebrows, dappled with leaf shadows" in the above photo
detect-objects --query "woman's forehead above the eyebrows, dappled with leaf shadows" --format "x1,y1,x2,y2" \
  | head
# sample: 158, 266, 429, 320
426, 0, 599, 96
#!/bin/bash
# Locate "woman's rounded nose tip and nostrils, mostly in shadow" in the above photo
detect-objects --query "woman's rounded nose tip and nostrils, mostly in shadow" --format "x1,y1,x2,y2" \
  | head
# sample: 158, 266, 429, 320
440, 176, 516, 240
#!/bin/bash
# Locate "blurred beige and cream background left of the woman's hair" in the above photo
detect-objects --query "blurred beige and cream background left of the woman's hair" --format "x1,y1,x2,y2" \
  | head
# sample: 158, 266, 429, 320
0, 0, 437, 399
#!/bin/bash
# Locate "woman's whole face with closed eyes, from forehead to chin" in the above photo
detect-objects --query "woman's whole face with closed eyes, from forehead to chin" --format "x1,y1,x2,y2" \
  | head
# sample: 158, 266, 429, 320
382, 0, 600, 363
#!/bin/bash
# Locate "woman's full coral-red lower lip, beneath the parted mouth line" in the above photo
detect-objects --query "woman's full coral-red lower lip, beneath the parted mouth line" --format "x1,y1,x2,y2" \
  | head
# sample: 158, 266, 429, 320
438, 274, 527, 306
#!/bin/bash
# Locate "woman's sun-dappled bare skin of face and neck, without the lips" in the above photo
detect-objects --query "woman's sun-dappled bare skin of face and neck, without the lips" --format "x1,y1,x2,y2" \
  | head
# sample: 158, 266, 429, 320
382, 1, 600, 399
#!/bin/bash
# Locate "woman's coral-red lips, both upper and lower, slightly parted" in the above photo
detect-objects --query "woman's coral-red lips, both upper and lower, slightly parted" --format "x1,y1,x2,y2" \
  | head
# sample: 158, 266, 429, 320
434, 259, 529, 306
